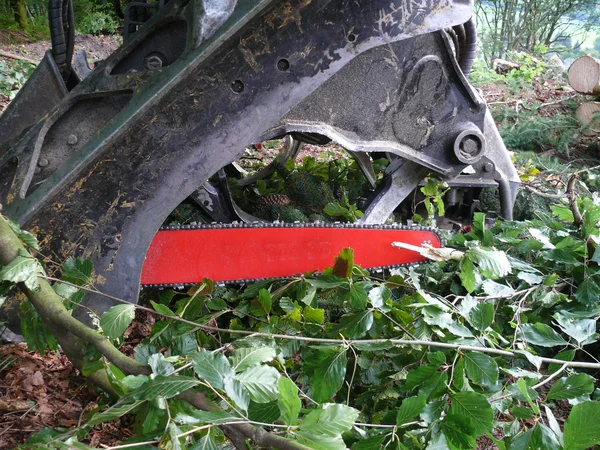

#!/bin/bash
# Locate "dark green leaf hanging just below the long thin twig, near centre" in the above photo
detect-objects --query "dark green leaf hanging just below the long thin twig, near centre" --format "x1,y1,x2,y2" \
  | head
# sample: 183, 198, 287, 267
303, 347, 347, 402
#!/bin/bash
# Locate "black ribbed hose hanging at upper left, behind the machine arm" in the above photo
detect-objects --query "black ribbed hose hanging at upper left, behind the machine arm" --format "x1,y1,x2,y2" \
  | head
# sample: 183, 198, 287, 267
48, 0, 75, 80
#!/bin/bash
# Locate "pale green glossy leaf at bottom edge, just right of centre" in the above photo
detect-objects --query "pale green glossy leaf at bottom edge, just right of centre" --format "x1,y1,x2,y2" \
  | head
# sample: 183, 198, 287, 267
299, 403, 359, 437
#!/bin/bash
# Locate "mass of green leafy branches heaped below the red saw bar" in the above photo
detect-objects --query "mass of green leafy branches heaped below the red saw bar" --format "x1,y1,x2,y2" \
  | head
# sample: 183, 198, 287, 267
8, 163, 600, 449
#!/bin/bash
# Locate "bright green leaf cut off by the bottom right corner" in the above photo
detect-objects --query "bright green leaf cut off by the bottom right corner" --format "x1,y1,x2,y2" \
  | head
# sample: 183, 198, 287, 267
564, 402, 600, 450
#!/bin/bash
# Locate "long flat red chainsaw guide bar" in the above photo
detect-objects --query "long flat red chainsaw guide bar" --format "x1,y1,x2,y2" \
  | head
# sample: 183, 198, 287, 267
141, 223, 442, 285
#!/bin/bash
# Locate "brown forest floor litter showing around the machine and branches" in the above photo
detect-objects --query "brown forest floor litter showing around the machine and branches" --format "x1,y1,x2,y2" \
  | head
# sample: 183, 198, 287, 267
0, 30, 600, 450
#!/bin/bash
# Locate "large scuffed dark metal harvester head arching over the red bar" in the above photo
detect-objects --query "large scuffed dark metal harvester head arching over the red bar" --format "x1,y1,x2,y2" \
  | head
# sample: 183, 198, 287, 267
0, 0, 518, 317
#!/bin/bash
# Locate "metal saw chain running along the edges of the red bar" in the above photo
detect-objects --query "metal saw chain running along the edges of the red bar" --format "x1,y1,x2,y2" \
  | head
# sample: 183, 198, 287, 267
141, 220, 444, 289
